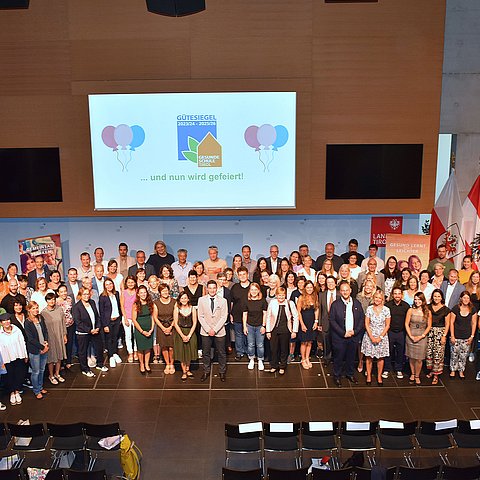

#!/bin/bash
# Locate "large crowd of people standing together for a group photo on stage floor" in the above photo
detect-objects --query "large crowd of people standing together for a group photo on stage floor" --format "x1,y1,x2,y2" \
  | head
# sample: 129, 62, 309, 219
0, 239, 480, 409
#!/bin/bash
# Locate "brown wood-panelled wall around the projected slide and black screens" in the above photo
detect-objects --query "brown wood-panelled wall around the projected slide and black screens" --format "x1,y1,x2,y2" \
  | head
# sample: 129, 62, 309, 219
0, 0, 445, 217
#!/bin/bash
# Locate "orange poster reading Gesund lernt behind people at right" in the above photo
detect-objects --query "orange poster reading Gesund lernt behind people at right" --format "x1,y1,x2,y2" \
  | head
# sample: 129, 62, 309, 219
385, 233, 430, 273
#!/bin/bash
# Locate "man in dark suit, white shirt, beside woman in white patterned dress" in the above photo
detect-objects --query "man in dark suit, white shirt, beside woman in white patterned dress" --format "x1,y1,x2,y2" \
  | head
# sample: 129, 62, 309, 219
329, 281, 365, 387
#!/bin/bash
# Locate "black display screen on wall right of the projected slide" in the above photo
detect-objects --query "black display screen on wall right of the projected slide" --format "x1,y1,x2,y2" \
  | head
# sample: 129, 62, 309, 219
325, 144, 423, 200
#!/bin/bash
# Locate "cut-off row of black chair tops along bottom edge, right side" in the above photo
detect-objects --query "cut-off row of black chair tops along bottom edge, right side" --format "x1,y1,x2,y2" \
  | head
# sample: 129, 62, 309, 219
222, 465, 480, 480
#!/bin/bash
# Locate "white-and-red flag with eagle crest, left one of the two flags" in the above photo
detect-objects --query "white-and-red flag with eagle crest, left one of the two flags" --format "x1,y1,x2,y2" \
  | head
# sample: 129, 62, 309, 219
430, 171, 465, 267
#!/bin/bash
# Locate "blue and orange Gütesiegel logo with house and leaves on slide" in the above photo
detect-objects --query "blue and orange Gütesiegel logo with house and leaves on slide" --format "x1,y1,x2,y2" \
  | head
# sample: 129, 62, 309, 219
177, 115, 222, 168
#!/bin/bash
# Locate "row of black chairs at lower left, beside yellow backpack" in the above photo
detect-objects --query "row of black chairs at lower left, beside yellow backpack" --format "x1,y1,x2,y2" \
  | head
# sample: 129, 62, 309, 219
0, 422, 122, 471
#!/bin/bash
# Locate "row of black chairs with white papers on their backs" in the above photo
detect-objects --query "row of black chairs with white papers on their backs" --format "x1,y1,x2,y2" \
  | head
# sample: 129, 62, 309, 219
225, 419, 480, 471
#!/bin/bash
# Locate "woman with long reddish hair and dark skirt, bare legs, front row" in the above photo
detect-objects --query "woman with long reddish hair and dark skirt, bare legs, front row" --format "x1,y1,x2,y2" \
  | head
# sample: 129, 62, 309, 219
297, 280, 320, 370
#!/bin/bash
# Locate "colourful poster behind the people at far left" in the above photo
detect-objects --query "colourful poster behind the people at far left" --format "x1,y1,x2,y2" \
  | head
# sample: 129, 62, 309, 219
18, 233, 63, 278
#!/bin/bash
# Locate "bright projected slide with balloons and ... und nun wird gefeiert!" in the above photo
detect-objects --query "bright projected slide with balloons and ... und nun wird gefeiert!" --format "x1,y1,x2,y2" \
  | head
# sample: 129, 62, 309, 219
89, 92, 296, 210
